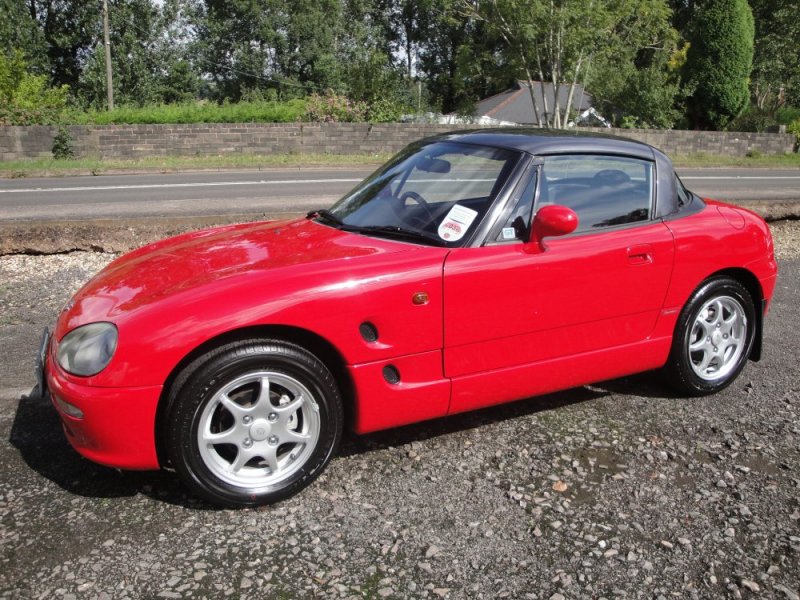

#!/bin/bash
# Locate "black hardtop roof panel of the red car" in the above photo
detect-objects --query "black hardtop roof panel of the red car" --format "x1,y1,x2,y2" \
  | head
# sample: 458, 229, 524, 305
428, 127, 661, 160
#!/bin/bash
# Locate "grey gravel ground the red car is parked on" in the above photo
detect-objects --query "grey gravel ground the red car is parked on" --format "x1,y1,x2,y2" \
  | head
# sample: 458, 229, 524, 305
0, 221, 800, 599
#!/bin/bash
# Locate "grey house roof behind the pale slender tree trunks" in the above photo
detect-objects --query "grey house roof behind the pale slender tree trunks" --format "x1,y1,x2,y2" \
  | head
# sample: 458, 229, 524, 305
475, 81, 592, 125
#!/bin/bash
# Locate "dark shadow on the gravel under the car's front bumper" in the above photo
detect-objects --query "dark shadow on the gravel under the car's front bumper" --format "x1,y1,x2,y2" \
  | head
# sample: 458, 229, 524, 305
9, 388, 215, 509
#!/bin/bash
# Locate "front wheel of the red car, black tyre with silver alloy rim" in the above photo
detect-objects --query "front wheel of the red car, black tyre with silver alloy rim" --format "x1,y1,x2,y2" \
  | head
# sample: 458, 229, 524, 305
162, 340, 344, 507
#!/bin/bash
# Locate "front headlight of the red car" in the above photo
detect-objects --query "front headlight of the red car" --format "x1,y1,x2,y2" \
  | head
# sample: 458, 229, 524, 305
56, 323, 117, 377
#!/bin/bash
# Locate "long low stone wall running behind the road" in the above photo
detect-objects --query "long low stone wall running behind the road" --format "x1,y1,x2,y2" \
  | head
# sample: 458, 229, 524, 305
0, 123, 795, 161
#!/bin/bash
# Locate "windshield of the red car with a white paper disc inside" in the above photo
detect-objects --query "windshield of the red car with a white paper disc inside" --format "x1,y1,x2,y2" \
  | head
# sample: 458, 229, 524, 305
317, 142, 520, 246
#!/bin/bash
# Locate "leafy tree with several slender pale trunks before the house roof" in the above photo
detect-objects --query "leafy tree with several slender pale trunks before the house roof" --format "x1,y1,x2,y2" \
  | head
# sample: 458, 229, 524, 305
462, 0, 671, 128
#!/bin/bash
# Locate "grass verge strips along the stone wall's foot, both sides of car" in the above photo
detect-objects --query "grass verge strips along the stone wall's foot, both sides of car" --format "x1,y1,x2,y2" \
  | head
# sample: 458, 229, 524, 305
0, 152, 800, 178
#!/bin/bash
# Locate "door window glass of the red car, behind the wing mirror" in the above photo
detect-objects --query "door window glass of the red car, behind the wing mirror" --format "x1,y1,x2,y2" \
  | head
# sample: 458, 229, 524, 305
537, 155, 653, 231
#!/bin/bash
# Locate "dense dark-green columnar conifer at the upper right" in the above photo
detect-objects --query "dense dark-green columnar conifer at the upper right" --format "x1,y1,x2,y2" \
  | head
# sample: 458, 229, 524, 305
684, 0, 755, 130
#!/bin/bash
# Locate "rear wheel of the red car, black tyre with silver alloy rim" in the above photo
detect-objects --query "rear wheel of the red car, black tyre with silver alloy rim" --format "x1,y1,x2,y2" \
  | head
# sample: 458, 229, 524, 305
664, 277, 756, 396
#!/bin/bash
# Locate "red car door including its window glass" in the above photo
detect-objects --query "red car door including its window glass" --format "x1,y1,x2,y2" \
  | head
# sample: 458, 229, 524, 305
443, 155, 674, 412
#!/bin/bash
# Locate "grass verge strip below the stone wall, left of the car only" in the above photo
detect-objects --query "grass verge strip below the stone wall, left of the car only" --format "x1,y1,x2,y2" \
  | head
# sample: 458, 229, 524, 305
0, 153, 390, 178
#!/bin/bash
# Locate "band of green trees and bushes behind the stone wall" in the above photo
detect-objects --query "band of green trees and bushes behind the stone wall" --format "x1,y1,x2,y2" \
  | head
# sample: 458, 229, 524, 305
0, 0, 800, 130
